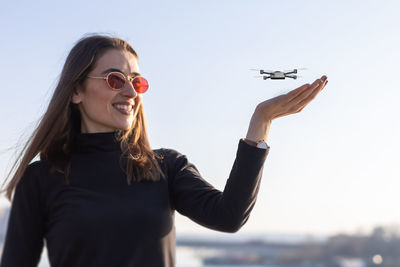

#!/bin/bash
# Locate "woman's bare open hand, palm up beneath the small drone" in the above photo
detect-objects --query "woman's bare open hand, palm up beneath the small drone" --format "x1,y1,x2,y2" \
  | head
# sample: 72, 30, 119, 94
246, 75, 328, 141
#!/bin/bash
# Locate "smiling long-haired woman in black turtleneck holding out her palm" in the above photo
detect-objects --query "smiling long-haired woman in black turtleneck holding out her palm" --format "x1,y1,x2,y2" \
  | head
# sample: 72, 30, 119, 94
0, 36, 327, 267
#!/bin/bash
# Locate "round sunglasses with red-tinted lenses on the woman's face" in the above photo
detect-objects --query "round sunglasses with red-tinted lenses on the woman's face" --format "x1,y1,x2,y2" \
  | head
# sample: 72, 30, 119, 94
87, 71, 149, 94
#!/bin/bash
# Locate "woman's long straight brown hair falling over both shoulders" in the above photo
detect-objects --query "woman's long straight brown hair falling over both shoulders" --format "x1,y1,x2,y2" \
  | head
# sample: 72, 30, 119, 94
1, 35, 163, 201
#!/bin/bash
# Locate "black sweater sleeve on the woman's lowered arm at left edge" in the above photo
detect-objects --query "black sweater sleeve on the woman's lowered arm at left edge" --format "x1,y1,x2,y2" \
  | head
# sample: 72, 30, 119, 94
0, 165, 44, 267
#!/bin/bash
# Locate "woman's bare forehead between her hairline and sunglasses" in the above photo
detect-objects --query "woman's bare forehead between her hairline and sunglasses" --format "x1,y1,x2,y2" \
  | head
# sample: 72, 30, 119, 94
94, 49, 139, 74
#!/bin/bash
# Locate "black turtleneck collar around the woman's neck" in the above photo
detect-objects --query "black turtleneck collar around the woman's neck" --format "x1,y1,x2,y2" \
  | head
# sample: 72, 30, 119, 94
72, 132, 121, 153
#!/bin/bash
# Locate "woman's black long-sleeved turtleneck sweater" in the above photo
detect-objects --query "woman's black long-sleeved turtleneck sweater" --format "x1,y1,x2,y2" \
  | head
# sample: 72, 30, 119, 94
0, 133, 268, 267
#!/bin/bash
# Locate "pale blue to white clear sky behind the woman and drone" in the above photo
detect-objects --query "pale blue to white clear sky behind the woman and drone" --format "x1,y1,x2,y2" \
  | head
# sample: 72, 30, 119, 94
0, 0, 400, 239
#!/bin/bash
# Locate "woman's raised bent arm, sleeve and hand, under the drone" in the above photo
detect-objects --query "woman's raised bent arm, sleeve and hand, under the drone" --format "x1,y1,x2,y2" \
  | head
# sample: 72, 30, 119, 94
168, 76, 327, 232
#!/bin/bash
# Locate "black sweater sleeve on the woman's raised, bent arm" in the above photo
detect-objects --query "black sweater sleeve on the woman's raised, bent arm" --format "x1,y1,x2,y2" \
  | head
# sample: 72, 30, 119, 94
166, 140, 269, 232
